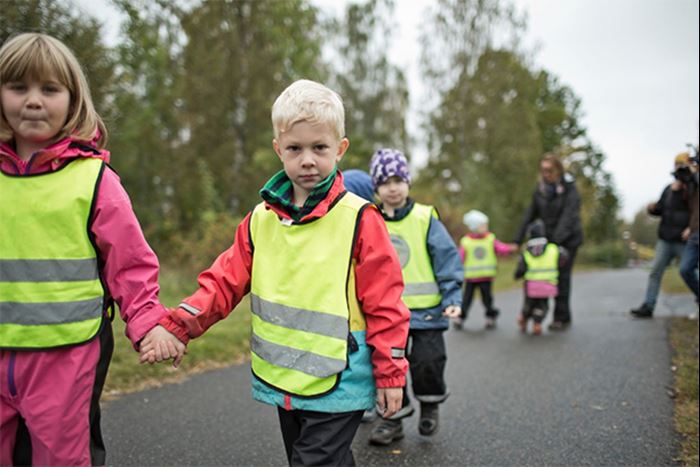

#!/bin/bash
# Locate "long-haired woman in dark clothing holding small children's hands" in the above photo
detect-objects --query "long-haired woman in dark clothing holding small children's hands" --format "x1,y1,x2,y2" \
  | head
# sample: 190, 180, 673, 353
514, 153, 583, 331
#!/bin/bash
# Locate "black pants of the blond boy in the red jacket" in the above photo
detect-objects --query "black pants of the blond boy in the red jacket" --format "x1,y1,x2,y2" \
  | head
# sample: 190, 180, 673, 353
277, 407, 363, 466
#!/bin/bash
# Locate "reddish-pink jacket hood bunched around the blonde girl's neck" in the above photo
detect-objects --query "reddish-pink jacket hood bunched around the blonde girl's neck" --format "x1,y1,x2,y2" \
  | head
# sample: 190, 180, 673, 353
0, 136, 110, 175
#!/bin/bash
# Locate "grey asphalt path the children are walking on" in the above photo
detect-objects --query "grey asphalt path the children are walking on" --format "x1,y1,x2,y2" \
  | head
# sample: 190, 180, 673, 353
102, 270, 696, 466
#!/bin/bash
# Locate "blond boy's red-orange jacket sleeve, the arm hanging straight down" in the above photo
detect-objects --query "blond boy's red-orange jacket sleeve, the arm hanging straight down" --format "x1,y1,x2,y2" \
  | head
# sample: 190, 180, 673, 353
354, 207, 411, 388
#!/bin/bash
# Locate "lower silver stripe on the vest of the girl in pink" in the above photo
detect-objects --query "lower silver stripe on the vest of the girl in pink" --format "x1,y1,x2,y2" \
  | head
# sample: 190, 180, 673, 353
0, 297, 102, 325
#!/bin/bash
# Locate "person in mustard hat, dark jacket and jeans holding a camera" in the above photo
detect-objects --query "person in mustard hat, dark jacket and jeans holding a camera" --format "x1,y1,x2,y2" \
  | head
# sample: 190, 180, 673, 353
630, 153, 690, 318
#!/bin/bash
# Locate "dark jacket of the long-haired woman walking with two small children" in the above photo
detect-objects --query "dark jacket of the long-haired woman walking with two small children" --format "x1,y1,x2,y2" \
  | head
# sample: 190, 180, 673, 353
515, 175, 583, 250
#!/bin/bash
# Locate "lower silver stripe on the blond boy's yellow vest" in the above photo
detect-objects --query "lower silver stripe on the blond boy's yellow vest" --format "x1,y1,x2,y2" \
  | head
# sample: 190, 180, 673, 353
250, 333, 346, 378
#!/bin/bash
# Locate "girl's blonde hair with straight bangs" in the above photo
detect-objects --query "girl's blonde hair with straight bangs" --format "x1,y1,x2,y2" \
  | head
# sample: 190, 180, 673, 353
0, 33, 107, 148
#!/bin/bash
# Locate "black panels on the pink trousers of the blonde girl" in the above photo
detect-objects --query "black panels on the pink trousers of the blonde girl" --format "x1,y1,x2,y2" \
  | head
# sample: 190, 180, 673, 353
12, 321, 114, 467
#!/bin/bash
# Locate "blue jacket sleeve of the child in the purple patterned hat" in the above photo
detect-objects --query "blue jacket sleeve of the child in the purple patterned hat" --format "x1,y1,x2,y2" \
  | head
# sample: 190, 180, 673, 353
428, 217, 464, 309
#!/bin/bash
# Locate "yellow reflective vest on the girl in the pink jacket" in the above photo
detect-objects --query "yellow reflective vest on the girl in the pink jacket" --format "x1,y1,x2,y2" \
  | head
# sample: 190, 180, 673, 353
0, 159, 105, 349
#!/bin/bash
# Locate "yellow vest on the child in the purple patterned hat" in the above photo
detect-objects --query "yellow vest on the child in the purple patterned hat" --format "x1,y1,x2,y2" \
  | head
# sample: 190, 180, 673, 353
386, 203, 442, 309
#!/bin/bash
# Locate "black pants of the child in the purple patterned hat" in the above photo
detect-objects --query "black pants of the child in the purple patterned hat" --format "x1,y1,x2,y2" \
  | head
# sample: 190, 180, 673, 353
402, 329, 447, 407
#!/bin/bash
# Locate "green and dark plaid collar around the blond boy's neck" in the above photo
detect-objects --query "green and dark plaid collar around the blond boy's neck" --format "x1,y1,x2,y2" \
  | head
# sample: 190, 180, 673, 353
260, 166, 338, 221
